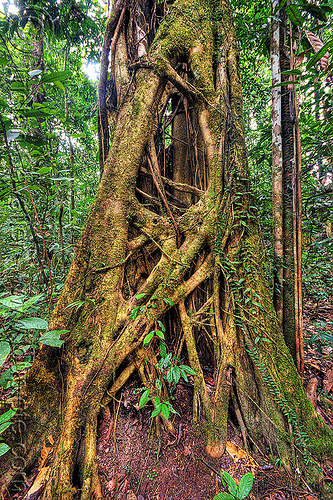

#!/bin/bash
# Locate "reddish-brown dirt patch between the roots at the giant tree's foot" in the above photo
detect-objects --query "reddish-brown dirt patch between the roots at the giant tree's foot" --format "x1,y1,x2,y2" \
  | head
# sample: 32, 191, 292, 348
92, 378, 322, 500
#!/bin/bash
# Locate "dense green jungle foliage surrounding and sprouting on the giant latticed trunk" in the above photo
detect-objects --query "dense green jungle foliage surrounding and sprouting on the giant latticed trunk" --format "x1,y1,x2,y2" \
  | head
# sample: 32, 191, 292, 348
0, 0, 333, 496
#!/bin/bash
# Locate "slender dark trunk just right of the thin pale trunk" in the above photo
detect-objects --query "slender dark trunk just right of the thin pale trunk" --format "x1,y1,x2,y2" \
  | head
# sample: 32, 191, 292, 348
280, 8, 304, 373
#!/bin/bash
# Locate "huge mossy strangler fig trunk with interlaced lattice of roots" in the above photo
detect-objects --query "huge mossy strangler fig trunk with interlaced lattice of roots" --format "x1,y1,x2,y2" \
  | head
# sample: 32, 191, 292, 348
1, 0, 333, 500
